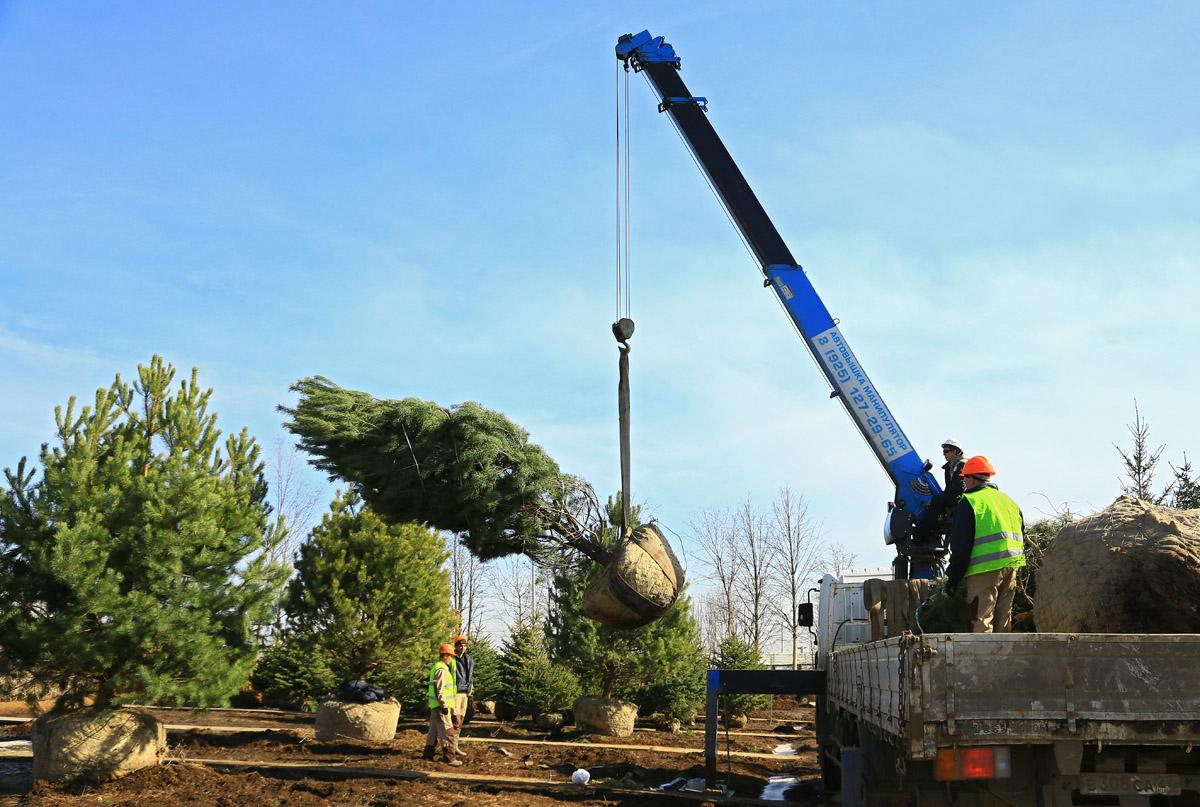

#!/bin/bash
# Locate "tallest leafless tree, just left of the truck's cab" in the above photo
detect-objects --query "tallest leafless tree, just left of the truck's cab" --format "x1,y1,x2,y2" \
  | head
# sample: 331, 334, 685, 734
767, 486, 824, 670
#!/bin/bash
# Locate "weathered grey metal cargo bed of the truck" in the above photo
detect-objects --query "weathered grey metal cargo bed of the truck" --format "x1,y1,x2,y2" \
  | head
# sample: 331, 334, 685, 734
828, 633, 1200, 759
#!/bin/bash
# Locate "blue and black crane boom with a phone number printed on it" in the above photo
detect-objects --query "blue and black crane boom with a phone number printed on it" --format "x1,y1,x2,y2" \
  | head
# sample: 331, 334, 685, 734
617, 31, 944, 578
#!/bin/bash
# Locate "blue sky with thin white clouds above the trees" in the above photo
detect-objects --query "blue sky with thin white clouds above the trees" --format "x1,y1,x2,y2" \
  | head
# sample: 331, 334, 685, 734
0, 1, 1200, 576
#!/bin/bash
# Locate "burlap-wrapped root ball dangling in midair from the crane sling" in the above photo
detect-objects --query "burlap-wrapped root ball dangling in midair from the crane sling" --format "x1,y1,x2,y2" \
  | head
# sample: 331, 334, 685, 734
583, 524, 684, 628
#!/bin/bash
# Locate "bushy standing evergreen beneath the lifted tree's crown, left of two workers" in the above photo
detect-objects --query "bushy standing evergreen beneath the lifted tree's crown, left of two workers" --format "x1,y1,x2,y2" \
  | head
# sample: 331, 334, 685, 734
286, 492, 451, 698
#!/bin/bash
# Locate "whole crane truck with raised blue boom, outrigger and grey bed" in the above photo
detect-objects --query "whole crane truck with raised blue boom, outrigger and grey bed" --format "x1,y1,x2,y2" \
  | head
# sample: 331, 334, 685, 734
617, 31, 1200, 807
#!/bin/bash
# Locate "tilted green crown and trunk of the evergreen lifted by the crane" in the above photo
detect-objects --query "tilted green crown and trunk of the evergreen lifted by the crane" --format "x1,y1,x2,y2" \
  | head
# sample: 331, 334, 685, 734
280, 376, 612, 566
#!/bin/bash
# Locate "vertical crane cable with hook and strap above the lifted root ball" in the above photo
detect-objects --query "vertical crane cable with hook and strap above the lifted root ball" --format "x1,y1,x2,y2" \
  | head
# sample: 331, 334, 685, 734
612, 62, 634, 542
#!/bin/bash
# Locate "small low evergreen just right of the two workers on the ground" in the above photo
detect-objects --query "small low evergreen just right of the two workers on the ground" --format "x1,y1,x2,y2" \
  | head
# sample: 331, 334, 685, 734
499, 622, 581, 716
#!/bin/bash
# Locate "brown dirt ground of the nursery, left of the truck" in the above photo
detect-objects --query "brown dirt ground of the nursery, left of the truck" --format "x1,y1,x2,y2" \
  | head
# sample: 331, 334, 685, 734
0, 704, 820, 807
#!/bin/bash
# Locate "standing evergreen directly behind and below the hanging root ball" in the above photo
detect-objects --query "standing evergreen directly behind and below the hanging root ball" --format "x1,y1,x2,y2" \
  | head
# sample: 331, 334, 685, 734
545, 497, 708, 722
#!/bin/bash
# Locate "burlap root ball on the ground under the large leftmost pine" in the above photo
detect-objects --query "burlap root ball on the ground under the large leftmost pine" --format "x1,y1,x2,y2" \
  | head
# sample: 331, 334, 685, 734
32, 709, 167, 782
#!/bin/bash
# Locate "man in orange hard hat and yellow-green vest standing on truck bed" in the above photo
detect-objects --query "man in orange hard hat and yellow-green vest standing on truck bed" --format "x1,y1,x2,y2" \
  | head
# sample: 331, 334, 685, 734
946, 455, 1025, 633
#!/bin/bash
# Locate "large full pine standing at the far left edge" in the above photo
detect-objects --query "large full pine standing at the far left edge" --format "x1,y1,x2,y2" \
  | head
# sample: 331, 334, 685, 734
0, 355, 287, 709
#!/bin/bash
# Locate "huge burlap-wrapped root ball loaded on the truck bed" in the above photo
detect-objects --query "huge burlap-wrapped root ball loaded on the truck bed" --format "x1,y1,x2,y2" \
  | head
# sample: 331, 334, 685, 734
1033, 496, 1200, 633
